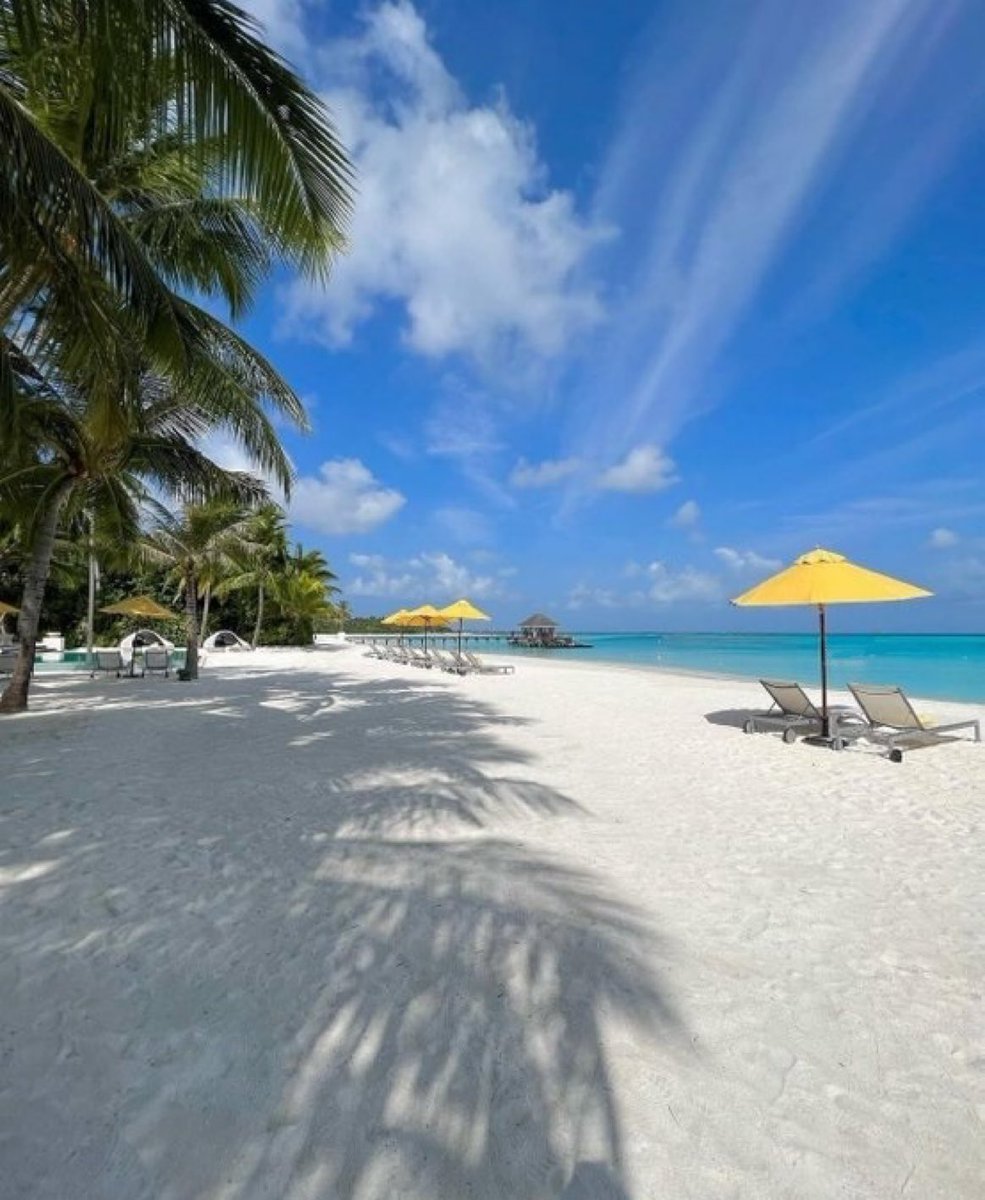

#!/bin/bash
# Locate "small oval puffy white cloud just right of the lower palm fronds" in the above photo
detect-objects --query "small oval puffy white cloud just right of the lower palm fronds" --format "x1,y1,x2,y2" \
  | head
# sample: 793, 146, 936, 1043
289, 458, 406, 535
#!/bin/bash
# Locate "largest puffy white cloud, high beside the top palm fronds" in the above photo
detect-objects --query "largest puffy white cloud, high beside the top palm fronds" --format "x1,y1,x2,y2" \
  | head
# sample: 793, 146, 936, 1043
272, 0, 603, 361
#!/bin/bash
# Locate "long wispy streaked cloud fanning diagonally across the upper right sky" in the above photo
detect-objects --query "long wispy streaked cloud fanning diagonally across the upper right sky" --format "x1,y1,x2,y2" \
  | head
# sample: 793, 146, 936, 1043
572, 0, 961, 457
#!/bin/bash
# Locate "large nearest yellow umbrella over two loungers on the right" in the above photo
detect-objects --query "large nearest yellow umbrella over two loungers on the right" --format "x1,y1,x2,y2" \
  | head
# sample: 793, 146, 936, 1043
732, 548, 933, 738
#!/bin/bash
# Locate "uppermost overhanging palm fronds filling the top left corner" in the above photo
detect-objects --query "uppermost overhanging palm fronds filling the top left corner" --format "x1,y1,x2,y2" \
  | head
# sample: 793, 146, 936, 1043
0, 0, 350, 379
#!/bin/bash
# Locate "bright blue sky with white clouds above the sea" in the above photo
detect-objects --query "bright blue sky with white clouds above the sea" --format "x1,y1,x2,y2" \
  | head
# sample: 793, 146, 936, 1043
226, 0, 985, 632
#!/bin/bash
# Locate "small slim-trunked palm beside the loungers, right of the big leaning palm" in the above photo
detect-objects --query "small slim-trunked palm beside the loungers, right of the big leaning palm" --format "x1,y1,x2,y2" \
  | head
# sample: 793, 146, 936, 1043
142, 500, 257, 679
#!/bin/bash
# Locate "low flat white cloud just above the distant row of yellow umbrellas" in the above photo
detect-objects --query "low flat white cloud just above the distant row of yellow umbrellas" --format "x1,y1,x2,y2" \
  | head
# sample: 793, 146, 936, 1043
346, 551, 511, 606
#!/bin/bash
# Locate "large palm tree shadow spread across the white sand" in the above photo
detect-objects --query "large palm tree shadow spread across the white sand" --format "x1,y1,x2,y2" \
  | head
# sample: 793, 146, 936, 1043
0, 672, 680, 1200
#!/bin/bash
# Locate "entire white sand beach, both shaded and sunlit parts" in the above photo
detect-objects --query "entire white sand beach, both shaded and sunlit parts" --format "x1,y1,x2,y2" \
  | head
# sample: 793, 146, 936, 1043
0, 649, 985, 1200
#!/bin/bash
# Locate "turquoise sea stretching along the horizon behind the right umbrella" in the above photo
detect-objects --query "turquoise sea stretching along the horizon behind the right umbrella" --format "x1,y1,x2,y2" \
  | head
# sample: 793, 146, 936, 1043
484, 631, 985, 703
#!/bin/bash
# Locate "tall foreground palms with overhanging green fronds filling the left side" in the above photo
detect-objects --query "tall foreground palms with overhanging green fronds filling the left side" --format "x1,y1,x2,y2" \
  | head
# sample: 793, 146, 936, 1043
0, 0, 350, 712
